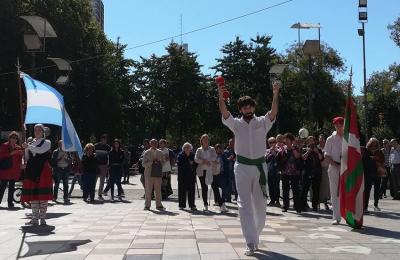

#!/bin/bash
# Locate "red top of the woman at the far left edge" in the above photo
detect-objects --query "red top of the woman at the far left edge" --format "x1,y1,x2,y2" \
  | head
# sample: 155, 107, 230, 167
0, 142, 23, 181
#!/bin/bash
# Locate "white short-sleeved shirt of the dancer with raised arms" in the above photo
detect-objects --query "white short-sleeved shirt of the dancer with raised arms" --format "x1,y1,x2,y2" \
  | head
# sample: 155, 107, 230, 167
222, 115, 275, 159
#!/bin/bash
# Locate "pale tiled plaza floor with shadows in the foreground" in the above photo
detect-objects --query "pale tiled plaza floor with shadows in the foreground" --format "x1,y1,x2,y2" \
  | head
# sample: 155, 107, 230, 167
0, 174, 400, 260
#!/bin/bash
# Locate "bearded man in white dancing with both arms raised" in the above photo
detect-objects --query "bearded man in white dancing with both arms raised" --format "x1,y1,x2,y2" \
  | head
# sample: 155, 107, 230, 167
218, 82, 280, 256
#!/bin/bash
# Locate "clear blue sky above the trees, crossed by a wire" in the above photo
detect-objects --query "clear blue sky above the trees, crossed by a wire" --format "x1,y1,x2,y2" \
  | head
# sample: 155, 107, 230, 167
103, 0, 400, 93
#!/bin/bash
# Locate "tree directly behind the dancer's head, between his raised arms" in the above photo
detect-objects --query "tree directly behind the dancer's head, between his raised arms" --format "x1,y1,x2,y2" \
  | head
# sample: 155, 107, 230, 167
213, 35, 278, 118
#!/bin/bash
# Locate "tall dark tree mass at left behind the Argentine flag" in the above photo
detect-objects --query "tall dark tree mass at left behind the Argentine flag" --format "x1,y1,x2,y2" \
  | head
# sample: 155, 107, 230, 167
0, 0, 136, 141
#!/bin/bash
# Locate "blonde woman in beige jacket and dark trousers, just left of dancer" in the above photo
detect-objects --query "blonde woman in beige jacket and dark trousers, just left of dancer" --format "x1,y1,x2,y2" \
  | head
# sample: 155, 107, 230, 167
194, 134, 217, 211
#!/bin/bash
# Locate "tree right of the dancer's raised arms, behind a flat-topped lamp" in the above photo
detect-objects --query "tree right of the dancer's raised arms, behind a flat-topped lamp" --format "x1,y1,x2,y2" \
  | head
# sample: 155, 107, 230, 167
281, 44, 345, 133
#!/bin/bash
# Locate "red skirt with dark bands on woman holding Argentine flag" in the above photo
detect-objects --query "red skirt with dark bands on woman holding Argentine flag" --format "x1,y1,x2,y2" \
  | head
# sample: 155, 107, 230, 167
21, 162, 53, 202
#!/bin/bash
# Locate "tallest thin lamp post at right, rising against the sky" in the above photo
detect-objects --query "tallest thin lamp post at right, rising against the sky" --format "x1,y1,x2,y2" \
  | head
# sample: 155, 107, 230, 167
358, 0, 369, 140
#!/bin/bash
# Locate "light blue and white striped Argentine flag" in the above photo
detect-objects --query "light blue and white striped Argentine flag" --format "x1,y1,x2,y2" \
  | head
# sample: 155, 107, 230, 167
21, 73, 83, 158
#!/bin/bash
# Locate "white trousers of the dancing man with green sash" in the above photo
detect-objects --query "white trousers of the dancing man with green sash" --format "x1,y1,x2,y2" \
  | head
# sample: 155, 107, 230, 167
234, 163, 267, 245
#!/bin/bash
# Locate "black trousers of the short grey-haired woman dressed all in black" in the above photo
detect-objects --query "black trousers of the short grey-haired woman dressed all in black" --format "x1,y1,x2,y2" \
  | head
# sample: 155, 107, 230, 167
178, 173, 196, 208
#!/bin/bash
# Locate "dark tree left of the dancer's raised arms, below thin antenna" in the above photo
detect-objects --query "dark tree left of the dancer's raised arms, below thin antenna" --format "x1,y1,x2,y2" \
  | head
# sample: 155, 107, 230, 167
133, 43, 209, 143
